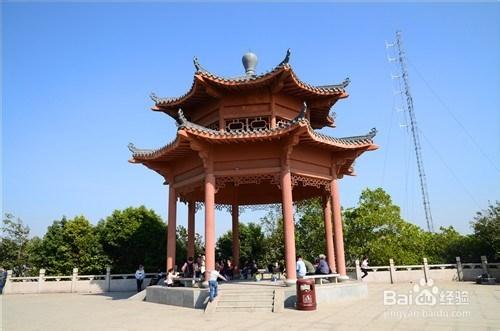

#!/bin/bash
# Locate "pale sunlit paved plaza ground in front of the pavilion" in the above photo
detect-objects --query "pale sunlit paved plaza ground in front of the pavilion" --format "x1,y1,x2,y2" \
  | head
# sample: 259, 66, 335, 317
1, 283, 500, 331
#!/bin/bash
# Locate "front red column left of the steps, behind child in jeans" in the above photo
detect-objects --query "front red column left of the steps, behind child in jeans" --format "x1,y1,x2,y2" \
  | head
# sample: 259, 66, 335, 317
205, 173, 215, 279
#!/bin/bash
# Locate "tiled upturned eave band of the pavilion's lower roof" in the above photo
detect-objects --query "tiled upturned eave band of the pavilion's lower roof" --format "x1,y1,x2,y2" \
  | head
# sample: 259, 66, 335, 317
129, 104, 378, 169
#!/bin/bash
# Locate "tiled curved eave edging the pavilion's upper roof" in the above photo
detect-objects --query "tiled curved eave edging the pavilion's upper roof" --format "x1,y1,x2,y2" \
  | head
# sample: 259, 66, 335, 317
152, 64, 348, 114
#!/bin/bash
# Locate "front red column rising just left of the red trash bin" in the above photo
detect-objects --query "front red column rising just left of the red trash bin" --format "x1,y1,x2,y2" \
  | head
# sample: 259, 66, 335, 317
281, 169, 297, 282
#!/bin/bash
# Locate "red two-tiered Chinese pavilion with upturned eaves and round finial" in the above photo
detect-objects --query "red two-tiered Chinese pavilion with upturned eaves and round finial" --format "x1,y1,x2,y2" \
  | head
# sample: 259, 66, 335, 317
129, 50, 377, 283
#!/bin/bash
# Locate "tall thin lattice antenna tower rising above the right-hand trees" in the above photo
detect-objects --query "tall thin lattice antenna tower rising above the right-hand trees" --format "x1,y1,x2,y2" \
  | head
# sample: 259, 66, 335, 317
386, 31, 434, 232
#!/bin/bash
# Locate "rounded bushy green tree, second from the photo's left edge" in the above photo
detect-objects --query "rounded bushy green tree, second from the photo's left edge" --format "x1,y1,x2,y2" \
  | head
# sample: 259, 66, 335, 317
32, 216, 108, 275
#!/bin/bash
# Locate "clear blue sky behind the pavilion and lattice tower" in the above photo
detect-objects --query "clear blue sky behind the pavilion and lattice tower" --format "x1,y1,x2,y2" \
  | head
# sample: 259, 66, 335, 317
2, 3, 500, 240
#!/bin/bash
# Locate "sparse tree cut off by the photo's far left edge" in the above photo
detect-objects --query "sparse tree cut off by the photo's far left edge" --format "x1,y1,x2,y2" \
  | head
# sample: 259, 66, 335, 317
0, 214, 30, 276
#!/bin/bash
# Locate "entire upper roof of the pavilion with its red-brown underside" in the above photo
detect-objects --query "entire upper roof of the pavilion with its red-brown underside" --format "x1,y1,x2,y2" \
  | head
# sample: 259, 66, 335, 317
151, 50, 350, 128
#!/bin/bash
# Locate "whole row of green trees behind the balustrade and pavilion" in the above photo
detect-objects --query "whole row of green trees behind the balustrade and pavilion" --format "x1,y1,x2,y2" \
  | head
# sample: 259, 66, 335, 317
0, 196, 500, 276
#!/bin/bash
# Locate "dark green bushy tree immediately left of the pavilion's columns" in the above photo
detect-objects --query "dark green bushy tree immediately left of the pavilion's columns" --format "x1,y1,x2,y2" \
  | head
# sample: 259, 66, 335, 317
97, 206, 166, 273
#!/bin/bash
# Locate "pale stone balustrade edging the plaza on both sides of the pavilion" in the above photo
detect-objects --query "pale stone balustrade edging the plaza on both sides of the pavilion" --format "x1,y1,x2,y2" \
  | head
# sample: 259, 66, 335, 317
3, 256, 500, 294
